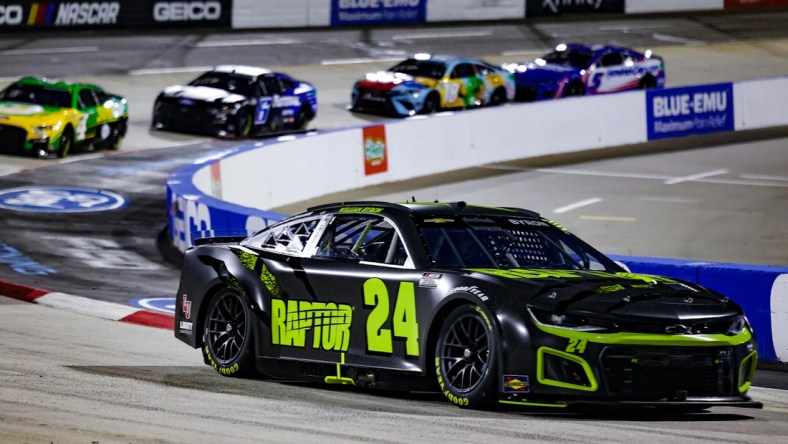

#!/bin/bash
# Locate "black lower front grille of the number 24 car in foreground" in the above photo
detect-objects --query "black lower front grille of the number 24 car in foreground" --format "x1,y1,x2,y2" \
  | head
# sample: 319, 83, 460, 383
601, 346, 735, 401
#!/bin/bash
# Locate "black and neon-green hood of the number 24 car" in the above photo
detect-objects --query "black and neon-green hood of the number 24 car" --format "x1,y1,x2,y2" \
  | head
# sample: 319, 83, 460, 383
462, 269, 742, 322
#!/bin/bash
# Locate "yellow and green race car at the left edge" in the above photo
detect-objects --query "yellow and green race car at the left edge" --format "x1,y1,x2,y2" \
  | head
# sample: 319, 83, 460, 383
0, 77, 128, 157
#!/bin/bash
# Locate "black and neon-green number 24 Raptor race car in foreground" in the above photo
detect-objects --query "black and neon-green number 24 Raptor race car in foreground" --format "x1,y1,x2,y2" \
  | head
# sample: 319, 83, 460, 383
175, 202, 760, 409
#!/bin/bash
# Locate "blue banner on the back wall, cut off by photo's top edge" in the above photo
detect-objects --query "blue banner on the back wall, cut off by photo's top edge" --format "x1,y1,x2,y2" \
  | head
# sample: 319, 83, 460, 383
331, 0, 427, 26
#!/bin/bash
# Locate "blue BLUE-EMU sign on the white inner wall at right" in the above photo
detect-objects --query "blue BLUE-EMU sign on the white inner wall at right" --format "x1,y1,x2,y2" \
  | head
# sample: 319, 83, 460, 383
646, 83, 734, 140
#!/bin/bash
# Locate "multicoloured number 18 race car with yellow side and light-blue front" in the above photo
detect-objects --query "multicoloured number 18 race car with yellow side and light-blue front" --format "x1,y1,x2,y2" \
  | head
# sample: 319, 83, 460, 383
350, 54, 514, 116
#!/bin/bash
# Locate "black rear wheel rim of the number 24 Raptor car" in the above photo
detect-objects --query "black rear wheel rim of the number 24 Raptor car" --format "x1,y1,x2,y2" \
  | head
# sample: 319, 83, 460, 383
206, 294, 246, 364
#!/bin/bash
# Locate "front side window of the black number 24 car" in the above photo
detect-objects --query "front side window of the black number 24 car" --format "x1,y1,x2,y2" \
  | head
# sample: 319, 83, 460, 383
315, 215, 408, 265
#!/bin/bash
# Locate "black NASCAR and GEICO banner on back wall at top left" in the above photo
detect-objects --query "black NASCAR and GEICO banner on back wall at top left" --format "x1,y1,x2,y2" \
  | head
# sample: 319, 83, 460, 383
0, 0, 232, 30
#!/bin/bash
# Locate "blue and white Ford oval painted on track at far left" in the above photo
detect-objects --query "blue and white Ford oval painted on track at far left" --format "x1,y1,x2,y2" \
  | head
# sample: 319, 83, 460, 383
0, 186, 127, 213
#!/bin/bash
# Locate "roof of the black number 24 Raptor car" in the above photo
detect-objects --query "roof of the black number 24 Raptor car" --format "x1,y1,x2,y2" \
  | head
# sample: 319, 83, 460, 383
308, 201, 540, 219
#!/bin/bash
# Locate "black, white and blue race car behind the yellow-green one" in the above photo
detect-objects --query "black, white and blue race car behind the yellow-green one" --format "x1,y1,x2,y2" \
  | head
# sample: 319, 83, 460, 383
152, 65, 317, 137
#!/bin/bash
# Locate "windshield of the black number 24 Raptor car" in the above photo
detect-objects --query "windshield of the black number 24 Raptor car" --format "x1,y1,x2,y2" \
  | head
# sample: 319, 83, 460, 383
418, 217, 623, 271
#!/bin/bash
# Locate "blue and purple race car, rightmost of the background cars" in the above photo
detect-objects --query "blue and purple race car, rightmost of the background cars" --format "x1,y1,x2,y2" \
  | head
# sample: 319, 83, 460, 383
504, 43, 665, 101
